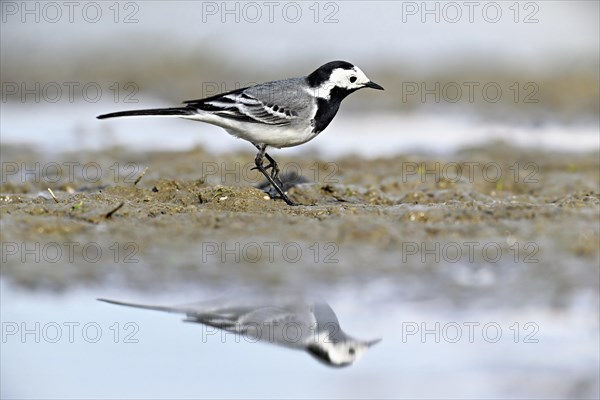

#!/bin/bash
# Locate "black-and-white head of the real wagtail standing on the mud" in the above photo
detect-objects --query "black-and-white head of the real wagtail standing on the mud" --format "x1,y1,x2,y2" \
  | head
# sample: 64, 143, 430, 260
306, 61, 383, 99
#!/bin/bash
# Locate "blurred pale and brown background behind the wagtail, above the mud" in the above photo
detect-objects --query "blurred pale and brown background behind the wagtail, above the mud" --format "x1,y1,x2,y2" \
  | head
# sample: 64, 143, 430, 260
0, 1, 600, 155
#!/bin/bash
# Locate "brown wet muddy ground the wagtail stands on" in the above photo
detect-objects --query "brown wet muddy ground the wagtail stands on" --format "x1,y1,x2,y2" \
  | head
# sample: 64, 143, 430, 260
0, 143, 600, 307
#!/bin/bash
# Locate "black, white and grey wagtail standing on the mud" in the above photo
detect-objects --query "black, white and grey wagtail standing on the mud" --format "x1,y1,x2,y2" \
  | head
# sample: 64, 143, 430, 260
98, 61, 383, 205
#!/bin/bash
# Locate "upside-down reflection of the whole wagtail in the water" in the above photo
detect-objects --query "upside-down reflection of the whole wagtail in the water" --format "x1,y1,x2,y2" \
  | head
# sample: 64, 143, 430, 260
98, 298, 381, 367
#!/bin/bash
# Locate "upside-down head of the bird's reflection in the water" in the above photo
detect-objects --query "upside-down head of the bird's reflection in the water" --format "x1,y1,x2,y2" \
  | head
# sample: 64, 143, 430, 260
307, 339, 381, 368
